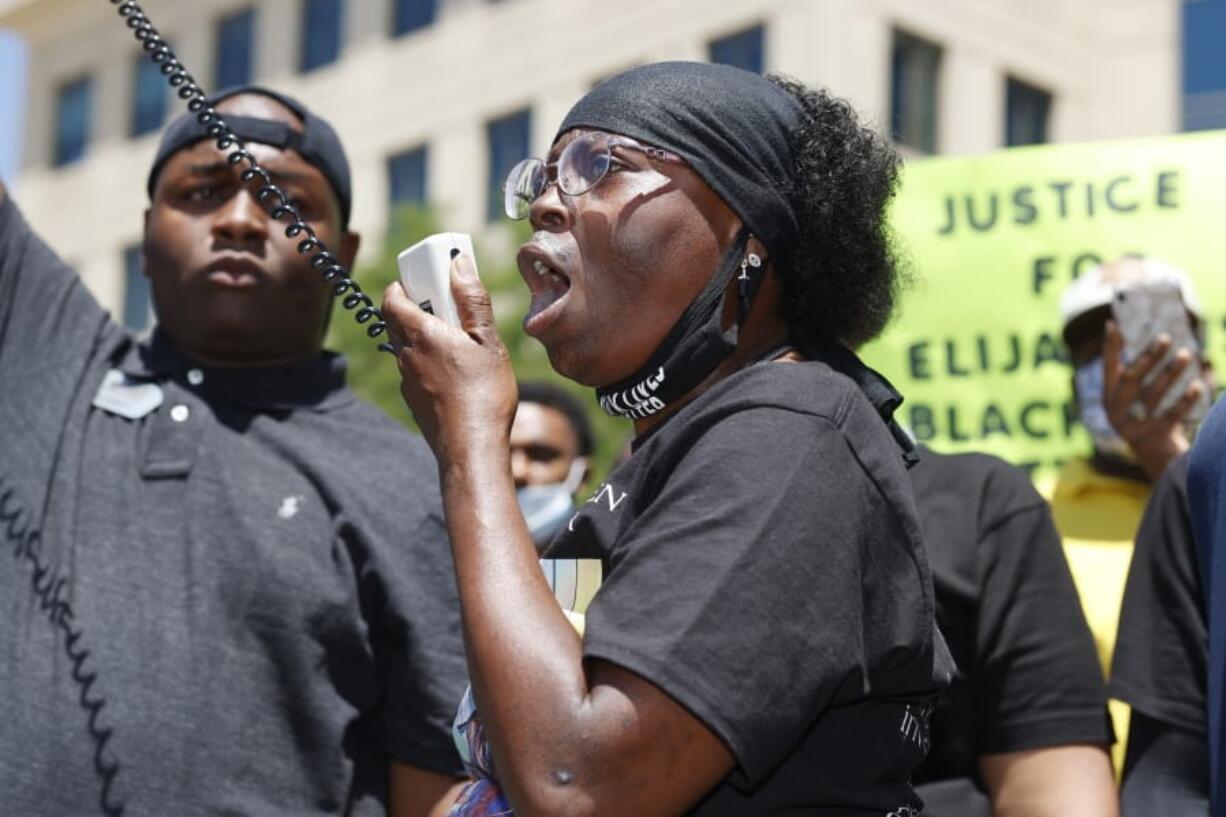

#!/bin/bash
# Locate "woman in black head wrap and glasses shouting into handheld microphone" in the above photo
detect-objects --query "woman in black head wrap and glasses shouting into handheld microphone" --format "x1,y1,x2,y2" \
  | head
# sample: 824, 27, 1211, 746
384, 63, 951, 817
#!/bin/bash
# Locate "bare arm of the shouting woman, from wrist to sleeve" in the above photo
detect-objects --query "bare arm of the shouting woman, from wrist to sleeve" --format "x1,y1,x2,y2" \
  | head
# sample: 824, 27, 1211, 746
440, 429, 732, 815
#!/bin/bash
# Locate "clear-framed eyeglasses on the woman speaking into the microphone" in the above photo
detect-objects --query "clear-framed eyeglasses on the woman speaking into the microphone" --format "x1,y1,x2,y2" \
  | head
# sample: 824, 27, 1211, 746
503, 131, 685, 221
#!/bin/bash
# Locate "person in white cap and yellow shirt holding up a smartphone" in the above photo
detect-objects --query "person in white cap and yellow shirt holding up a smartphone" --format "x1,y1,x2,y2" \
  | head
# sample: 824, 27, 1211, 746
1040, 255, 1211, 769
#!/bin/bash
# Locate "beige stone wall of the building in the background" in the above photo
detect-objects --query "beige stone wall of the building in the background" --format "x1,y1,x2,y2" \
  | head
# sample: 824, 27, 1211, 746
0, 0, 1179, 309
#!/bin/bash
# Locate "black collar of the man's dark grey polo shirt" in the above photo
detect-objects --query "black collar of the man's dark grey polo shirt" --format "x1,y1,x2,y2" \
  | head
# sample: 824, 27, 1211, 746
119, 329, 354, 411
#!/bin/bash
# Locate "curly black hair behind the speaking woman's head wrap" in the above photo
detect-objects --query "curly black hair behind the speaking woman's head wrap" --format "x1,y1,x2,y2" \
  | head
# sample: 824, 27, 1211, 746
769, 76, 904, 348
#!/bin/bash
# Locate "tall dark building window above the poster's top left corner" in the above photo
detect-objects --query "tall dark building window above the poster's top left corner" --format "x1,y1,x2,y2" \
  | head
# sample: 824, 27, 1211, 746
890, 31, 940, 153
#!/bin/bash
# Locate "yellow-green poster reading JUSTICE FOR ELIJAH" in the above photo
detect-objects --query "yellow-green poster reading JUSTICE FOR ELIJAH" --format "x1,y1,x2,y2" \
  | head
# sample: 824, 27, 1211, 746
864, 131, 1226, 478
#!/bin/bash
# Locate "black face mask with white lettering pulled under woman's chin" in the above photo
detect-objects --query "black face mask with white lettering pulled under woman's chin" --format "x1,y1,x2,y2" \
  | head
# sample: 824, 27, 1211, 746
596, 228, 763, 420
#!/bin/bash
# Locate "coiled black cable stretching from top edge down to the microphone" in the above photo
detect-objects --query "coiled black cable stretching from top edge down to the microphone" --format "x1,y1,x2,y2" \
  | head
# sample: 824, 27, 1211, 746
110, 0, 392, 352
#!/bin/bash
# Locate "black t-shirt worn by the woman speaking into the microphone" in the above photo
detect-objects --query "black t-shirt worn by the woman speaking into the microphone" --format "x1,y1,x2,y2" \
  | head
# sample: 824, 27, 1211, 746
552, 362, 951, 817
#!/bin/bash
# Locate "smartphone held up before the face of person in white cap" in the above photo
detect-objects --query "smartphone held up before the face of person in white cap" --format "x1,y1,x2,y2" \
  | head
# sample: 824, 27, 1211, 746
1111, 281, 1209, 423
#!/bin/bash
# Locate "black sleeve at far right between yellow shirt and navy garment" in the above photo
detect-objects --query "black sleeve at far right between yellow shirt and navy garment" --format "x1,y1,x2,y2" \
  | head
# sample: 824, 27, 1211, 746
1110, 455, 1209, 736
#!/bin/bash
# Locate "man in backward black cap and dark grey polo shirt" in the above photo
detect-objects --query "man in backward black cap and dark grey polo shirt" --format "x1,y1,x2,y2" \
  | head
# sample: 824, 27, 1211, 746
0, 88, 465, 816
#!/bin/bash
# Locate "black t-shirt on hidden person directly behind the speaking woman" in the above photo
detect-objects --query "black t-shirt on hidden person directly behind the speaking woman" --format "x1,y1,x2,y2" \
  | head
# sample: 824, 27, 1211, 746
911, 451, 1112, 815
